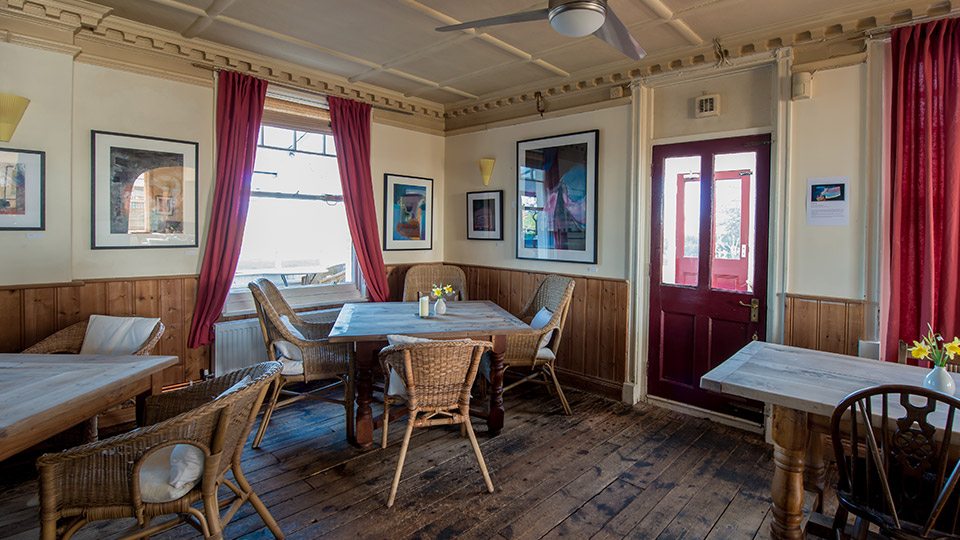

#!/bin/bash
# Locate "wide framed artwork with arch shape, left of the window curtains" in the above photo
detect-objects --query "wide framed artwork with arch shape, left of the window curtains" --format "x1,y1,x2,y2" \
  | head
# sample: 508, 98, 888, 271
91, 131, 199, 249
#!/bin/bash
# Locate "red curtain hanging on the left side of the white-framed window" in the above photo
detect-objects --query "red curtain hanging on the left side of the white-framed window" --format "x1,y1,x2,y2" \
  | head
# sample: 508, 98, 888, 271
187, 71, 267, 348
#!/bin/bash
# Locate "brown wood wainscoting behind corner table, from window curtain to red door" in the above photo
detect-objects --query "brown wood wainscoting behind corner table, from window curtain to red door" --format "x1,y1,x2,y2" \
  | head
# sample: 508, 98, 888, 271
387, 263, 629, 399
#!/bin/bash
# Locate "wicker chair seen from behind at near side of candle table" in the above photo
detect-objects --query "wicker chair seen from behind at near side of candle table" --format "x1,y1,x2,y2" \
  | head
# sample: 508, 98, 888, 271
380, 340, 493, 508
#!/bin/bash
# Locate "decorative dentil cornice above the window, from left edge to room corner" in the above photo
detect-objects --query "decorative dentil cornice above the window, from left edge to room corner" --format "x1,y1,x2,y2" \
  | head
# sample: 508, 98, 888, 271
0, 0, 443, 123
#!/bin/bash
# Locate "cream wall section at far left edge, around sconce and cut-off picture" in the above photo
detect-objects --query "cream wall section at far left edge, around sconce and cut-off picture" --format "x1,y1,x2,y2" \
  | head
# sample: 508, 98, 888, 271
0, 43, 73, 285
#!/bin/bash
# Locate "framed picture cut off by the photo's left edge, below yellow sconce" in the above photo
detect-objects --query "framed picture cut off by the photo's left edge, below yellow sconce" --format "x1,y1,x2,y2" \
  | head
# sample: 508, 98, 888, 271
0, 148, 46, 231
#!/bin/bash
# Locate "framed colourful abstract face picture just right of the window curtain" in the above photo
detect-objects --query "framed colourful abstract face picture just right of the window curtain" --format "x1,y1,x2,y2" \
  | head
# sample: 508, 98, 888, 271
383, 173, 433, 251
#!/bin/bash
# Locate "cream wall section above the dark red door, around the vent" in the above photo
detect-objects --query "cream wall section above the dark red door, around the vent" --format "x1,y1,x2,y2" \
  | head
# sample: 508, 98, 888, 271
653, 66, 775, 139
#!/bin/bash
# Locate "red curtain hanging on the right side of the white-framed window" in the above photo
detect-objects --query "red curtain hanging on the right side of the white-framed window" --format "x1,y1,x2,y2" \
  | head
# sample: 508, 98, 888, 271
327, 96, 390, 302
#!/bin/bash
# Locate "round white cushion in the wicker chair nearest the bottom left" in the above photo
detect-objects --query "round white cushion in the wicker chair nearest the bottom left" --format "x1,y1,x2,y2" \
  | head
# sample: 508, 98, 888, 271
140, 444, 203, 503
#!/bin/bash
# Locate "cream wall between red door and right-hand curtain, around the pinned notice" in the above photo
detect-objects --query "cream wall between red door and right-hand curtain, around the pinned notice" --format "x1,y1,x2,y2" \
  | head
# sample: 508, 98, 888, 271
787, 64, 879, 298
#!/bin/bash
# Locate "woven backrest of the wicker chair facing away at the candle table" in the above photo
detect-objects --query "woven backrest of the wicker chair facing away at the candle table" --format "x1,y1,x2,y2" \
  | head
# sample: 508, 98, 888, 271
380, 339, 493, 413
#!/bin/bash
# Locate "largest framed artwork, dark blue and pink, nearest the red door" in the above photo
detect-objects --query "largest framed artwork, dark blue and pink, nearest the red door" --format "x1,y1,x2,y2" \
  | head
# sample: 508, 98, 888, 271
517, 130, 599, 264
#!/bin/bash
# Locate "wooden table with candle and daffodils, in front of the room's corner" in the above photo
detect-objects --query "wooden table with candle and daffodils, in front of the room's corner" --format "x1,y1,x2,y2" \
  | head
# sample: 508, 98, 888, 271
329, 300, 531, 448
